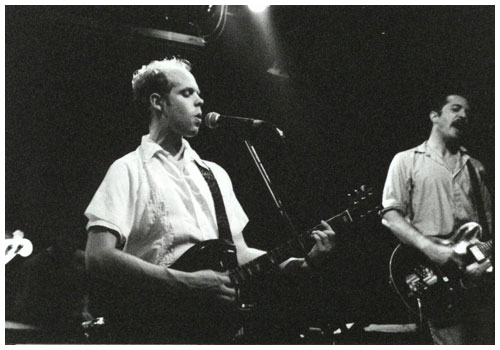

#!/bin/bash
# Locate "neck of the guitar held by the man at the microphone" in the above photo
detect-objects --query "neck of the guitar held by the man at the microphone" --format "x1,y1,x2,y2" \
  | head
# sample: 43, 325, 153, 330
231, 210, 353, 284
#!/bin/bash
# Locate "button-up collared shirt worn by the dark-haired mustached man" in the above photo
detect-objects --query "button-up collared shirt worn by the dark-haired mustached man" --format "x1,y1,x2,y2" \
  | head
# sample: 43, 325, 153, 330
382, 141, 492, 236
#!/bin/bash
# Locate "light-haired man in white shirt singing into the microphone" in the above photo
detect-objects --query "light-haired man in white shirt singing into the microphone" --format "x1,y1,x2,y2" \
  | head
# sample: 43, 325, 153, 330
85, 58, 334, 344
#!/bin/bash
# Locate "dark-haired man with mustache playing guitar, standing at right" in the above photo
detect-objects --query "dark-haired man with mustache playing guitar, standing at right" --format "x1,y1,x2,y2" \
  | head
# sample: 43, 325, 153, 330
381, 94, 494, 344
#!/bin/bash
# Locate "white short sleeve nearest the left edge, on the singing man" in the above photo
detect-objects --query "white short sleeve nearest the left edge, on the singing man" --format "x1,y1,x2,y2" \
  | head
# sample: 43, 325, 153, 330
85, 160, 136, 243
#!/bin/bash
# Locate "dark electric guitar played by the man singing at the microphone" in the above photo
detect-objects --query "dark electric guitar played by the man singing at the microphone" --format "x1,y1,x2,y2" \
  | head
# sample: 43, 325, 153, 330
170, 186, 377, 311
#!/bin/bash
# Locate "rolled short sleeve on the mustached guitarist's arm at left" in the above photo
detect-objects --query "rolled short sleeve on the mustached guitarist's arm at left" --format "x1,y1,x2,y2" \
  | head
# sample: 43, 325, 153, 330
381, 152, 411, 216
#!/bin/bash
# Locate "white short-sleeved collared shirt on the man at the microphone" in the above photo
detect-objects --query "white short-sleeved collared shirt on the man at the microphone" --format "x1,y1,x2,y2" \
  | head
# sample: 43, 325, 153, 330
85, 135, 248, 266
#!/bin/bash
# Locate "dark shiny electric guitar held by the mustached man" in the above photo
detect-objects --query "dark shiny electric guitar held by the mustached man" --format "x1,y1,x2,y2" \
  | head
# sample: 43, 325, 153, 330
389, 222, 493, 319
